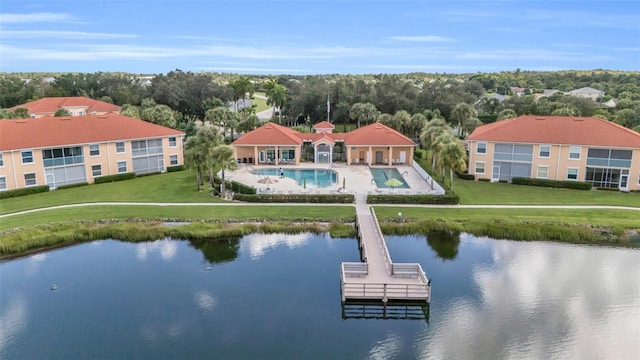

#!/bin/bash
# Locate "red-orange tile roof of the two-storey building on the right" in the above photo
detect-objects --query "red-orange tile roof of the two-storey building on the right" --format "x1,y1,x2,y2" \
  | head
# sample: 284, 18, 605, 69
468, 115, 640, 148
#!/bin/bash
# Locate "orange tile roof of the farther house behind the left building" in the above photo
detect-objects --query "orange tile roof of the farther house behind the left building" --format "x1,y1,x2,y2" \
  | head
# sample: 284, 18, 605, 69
10, 96, 121, 115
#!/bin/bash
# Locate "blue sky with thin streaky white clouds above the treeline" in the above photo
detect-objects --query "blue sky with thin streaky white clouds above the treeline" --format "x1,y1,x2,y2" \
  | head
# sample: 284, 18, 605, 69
0, 0, 640, 75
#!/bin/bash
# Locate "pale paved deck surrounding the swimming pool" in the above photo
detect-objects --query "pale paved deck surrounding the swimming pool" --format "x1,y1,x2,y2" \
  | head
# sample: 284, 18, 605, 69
225, 163, 438, 195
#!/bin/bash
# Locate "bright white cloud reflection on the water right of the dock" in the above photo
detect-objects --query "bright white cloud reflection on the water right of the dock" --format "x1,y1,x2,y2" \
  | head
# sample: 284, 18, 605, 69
422, 239, 640, 359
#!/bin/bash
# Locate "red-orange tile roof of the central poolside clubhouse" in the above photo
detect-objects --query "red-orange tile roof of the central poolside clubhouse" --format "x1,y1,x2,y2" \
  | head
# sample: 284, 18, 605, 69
231, 123, 415, 146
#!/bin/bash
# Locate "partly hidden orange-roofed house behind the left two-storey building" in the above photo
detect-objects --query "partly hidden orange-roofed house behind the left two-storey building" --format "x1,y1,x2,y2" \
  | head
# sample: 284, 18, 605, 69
9, 96, 122, 118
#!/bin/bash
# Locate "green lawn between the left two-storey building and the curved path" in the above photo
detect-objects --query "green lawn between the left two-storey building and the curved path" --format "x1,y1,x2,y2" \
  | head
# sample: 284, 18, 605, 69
0, 170, 223, 215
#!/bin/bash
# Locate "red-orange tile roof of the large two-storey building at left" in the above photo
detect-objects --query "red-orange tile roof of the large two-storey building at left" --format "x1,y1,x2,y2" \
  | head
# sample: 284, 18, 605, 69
0, 114, 184, 151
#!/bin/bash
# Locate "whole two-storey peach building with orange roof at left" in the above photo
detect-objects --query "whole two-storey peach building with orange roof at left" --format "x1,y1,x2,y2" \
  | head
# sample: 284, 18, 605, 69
0, 114, 184, 191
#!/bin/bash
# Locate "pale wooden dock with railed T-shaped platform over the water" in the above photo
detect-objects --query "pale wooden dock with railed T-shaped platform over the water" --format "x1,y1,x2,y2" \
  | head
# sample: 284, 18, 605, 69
340, 205, 431, 304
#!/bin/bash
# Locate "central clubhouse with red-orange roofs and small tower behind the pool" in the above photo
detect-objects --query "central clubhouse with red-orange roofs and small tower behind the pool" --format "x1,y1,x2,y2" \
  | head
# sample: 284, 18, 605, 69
231, 121, 415, 166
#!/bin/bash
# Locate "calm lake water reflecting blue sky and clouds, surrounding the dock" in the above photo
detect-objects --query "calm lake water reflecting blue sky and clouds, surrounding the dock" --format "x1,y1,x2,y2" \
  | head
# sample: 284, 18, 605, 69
0, 234, 640, 359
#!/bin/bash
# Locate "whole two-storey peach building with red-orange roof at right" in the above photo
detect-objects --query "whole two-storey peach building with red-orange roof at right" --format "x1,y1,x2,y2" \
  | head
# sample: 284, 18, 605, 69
467, 115, 640, 191
